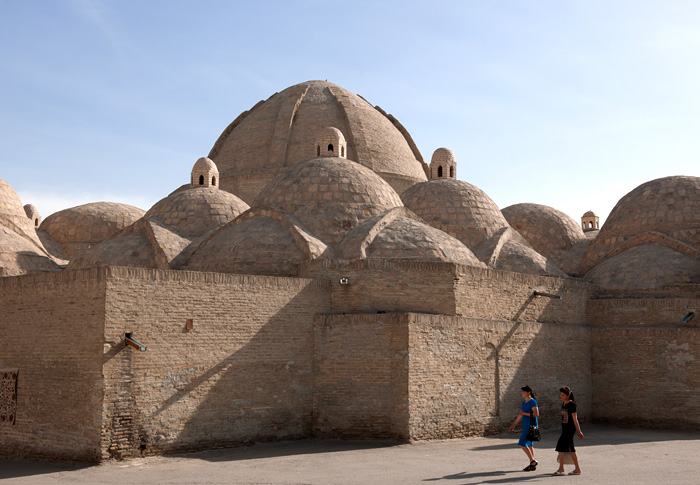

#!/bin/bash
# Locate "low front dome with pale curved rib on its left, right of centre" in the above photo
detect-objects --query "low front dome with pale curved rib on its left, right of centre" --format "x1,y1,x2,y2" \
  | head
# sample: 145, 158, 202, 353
337, 207, 484, 267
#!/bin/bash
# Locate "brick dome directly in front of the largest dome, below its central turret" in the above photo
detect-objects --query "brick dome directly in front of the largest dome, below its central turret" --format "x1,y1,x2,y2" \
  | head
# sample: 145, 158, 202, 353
254, 157, 403, 246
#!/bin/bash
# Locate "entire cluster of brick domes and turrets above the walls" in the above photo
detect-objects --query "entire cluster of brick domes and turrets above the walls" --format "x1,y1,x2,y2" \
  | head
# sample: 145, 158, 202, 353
0, 81, 700, 291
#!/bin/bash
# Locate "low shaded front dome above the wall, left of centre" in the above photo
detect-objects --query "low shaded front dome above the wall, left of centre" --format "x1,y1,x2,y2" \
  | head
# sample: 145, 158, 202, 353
184, 207, 328, 276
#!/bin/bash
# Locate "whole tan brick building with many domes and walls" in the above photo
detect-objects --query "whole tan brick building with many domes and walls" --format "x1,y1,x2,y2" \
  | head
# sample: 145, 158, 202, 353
0, 81, 700, 461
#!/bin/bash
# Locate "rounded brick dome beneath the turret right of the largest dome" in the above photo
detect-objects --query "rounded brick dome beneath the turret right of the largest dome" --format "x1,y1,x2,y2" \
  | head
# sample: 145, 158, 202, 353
401, 179, 508, 250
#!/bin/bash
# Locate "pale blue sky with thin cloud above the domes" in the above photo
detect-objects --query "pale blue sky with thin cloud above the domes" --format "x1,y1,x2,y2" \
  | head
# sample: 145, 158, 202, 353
0, 0, 700, 225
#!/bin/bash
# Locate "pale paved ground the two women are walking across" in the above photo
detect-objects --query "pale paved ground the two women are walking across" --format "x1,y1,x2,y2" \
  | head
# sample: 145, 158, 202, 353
0, 425, 700, 485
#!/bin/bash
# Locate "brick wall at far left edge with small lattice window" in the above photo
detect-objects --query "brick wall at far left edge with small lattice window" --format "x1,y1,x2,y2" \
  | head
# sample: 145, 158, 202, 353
0, 269, 105, 461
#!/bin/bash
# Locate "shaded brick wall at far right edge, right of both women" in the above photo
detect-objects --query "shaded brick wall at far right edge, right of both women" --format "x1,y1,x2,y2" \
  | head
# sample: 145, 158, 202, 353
588, 299, 700, 430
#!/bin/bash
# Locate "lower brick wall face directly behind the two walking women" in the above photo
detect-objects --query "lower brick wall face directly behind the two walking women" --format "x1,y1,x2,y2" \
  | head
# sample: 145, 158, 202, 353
409, 314, 592, 439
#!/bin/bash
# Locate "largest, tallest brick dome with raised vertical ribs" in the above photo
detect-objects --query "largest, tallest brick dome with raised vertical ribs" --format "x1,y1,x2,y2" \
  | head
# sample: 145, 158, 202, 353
209, 81, 427, 204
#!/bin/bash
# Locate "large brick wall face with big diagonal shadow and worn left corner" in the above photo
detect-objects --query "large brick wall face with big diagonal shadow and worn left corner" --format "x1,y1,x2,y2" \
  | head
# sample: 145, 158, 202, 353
102, 268, 329, 458
